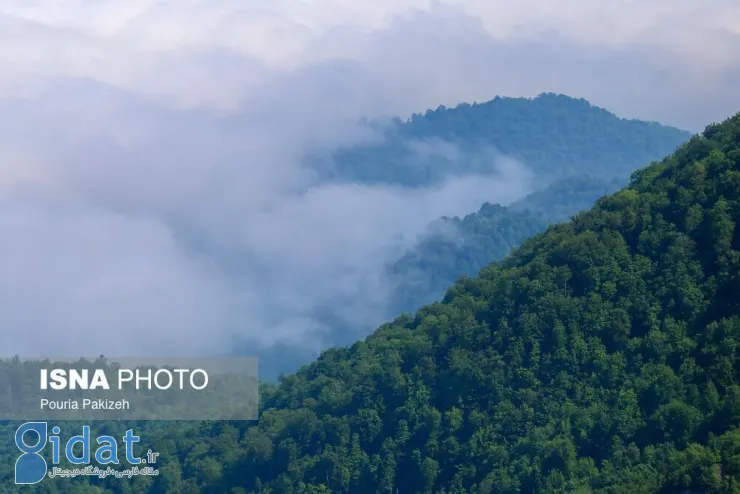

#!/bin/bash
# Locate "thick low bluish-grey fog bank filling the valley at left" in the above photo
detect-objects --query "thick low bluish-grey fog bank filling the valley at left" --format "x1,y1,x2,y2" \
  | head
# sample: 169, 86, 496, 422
0, 77, 531, 362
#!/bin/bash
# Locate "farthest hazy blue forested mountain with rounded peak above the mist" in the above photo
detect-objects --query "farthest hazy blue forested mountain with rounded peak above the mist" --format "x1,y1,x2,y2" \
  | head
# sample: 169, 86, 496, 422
310, 93, 690, 187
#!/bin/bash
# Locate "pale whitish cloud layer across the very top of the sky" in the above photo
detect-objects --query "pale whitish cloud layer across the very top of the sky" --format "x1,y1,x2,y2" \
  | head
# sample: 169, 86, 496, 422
0, 0, 740, 124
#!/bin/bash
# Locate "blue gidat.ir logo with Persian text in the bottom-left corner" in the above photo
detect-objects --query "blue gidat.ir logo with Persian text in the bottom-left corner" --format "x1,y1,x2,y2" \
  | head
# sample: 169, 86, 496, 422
15, 422, 158, 484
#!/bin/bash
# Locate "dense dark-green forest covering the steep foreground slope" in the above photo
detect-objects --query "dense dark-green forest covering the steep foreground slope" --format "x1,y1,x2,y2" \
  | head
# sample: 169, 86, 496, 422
3, 114, 740, 494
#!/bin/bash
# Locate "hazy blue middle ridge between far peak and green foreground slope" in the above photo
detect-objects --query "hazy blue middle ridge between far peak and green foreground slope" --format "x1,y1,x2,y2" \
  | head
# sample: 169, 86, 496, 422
388, 176, 622, 316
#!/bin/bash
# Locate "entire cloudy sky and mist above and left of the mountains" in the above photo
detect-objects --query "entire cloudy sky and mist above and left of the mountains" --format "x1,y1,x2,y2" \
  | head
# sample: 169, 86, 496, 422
0, 0, 740, 362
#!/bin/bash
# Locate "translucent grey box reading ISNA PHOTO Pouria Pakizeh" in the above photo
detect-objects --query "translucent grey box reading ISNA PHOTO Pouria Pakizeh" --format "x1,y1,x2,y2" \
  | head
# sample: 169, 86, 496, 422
0, 357, 259, 421
